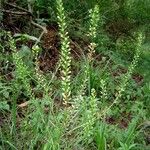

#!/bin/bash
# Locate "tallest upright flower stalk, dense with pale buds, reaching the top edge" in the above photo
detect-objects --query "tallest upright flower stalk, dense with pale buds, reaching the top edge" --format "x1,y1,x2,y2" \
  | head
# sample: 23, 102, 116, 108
56, 0, 71, 104
